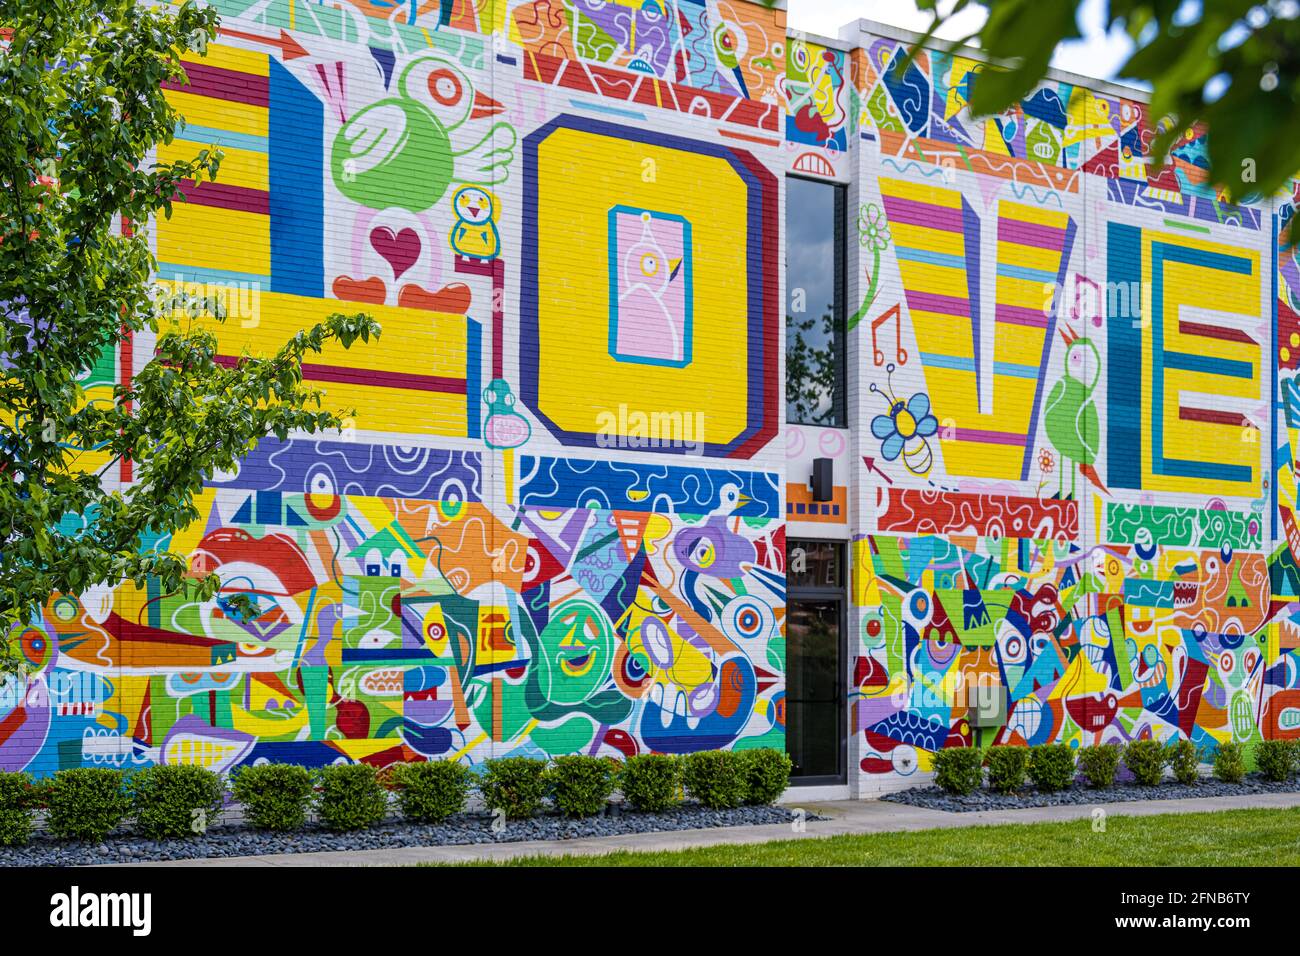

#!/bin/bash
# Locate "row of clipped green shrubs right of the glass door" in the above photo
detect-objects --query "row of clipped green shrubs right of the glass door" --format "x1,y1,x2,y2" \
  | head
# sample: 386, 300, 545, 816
935, 740, 1300, 795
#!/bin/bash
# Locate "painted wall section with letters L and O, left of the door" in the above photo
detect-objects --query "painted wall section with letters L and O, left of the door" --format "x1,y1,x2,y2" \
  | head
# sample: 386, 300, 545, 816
0, 0, 785, 774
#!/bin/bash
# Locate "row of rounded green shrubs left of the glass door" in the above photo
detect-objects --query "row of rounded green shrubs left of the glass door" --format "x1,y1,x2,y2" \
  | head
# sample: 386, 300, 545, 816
0, 749, 790, 845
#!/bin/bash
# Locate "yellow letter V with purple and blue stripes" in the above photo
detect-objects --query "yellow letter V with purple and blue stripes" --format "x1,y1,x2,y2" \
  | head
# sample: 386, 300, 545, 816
880, 177, 1076, 481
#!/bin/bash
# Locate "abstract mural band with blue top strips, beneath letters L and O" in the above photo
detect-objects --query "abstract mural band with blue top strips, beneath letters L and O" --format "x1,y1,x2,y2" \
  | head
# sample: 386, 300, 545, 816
0, 442, 784, 771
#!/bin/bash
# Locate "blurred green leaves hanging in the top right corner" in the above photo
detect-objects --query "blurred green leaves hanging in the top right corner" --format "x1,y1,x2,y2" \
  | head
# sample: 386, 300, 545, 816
898, 0, 1300, 209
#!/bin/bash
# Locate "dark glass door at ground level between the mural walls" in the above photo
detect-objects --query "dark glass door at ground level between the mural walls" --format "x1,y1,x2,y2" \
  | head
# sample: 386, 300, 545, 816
785, 541, 848, 784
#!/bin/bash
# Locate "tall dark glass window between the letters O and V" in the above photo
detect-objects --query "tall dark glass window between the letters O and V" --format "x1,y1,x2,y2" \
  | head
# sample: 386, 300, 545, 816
785, 177, 846, 428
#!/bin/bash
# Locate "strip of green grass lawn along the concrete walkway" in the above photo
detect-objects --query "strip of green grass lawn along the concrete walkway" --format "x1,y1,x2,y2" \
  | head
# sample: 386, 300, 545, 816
434, 808, 1300, 866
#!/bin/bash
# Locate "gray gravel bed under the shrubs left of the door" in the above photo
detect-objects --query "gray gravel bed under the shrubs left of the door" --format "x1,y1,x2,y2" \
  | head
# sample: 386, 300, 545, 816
0, 804, 820, 866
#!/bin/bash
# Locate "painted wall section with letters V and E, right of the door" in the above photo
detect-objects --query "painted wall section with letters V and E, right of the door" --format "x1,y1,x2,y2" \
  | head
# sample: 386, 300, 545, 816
852, 33, 1284, 786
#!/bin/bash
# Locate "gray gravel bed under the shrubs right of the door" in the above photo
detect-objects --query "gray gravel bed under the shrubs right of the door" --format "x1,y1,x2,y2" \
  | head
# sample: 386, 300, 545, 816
880, 774, 1300, 813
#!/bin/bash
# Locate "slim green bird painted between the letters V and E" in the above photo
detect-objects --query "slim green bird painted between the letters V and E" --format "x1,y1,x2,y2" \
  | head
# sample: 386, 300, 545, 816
1043, 329, 1109, 498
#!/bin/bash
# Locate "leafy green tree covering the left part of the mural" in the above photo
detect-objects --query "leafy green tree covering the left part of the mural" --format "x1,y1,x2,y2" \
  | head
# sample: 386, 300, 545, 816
0, 0, 380, 674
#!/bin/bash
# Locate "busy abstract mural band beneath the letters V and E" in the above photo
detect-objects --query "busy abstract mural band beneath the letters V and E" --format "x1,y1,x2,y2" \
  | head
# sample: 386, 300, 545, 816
854, 528, 1268, 773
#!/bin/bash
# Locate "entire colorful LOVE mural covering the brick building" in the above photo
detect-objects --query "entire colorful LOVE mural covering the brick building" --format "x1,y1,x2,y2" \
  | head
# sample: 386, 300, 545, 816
0, 0, 1300, 795
